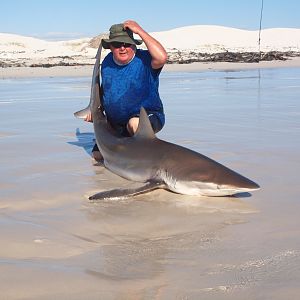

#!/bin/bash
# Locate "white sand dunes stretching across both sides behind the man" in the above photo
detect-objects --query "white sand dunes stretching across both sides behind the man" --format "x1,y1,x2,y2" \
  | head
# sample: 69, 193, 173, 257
0, 25, 300, 60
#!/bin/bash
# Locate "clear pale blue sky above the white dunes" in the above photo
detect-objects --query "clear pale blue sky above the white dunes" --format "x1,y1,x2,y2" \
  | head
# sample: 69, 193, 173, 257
0, 0, 300, 39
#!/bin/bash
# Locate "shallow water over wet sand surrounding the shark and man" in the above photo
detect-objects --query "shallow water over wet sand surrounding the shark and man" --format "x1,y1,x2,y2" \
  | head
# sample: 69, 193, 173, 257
0, 68, 300, 299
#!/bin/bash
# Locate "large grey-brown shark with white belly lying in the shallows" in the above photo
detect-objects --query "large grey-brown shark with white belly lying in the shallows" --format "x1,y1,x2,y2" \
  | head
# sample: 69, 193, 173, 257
75, 45, 259, 200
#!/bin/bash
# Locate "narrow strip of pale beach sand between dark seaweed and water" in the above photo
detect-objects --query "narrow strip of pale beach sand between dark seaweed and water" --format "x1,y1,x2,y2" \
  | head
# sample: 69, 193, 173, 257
0, 57, 300, 79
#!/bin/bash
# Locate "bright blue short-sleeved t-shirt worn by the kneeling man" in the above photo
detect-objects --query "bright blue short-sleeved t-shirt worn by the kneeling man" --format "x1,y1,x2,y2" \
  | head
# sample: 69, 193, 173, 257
101, 49, 165, 125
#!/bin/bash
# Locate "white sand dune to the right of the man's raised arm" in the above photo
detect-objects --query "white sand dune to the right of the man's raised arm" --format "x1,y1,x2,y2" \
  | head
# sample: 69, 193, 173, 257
153, 25, 300, 53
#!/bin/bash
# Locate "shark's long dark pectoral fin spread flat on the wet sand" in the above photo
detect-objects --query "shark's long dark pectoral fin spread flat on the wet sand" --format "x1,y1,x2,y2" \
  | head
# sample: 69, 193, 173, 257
89, 181, 165, 200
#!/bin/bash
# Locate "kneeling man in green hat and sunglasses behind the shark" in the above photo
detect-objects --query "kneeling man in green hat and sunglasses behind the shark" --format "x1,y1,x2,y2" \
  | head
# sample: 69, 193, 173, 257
85, 20, 167, 160
